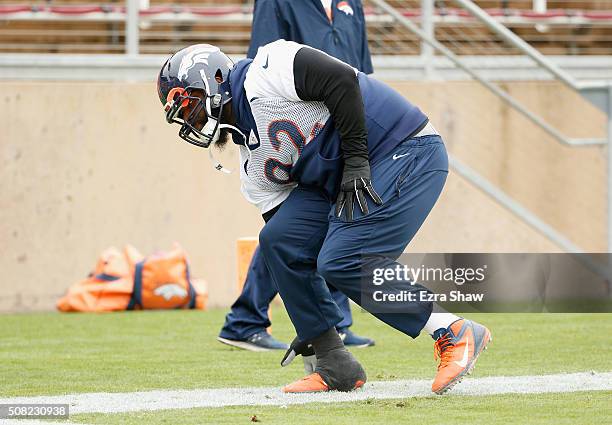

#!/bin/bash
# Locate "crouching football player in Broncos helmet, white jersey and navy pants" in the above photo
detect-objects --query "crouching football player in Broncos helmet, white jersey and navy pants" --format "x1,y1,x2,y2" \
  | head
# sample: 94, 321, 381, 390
158, 40, 491, 393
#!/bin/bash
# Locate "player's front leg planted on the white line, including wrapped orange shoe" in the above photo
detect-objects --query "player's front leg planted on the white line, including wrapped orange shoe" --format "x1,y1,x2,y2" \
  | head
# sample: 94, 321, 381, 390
259, 186, 366, 392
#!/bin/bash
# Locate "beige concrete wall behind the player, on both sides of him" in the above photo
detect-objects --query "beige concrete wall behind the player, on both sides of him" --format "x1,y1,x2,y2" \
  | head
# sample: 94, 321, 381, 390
0, 81, 605, 311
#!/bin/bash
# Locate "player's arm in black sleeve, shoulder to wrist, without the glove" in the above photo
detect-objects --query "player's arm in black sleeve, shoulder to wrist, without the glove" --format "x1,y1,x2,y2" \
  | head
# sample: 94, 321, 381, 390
293, 47, 368, 167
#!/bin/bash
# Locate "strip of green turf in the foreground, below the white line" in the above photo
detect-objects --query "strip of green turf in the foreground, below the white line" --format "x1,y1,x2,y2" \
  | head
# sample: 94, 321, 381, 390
70, 391, 612, 425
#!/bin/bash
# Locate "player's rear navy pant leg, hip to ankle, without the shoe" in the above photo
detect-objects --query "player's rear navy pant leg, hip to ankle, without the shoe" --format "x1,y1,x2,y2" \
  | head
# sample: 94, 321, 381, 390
318, 136, 447, 338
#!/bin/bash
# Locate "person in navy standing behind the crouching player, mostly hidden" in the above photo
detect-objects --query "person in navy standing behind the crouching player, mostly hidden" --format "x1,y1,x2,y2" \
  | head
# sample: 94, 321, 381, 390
217, 0, 374, 351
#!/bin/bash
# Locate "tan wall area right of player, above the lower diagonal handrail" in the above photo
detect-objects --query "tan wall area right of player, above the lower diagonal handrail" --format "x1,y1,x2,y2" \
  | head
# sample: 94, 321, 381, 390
394, 82, 607, 252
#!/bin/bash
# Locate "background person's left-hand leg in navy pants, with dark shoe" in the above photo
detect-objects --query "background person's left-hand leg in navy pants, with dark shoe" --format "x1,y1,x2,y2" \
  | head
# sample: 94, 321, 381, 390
219, 247, 288, 351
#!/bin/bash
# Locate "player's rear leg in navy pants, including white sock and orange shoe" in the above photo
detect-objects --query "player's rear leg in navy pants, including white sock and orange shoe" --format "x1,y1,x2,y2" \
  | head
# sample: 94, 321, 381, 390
318, 136, 491, 394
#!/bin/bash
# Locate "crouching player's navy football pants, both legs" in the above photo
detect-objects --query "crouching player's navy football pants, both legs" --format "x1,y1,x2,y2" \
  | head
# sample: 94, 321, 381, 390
259, 136, 448, 340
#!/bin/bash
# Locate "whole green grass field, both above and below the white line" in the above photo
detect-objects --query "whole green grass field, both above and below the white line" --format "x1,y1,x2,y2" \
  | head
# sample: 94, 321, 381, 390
0, 308, 612, 424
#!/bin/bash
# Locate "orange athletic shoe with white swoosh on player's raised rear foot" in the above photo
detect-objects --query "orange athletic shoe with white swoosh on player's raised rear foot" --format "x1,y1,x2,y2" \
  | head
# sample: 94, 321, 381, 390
431, 319, 492, 394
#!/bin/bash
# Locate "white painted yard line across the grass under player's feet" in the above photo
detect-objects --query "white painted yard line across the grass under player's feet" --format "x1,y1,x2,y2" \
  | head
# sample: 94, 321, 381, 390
0, 372, 612, 423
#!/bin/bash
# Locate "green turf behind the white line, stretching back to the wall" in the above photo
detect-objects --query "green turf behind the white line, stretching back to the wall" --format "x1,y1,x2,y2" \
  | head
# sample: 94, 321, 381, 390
0, 306, 612, 396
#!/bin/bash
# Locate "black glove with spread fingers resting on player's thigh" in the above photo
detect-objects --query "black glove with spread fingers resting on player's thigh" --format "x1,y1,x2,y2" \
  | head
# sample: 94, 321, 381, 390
336, 160, 382, 221
